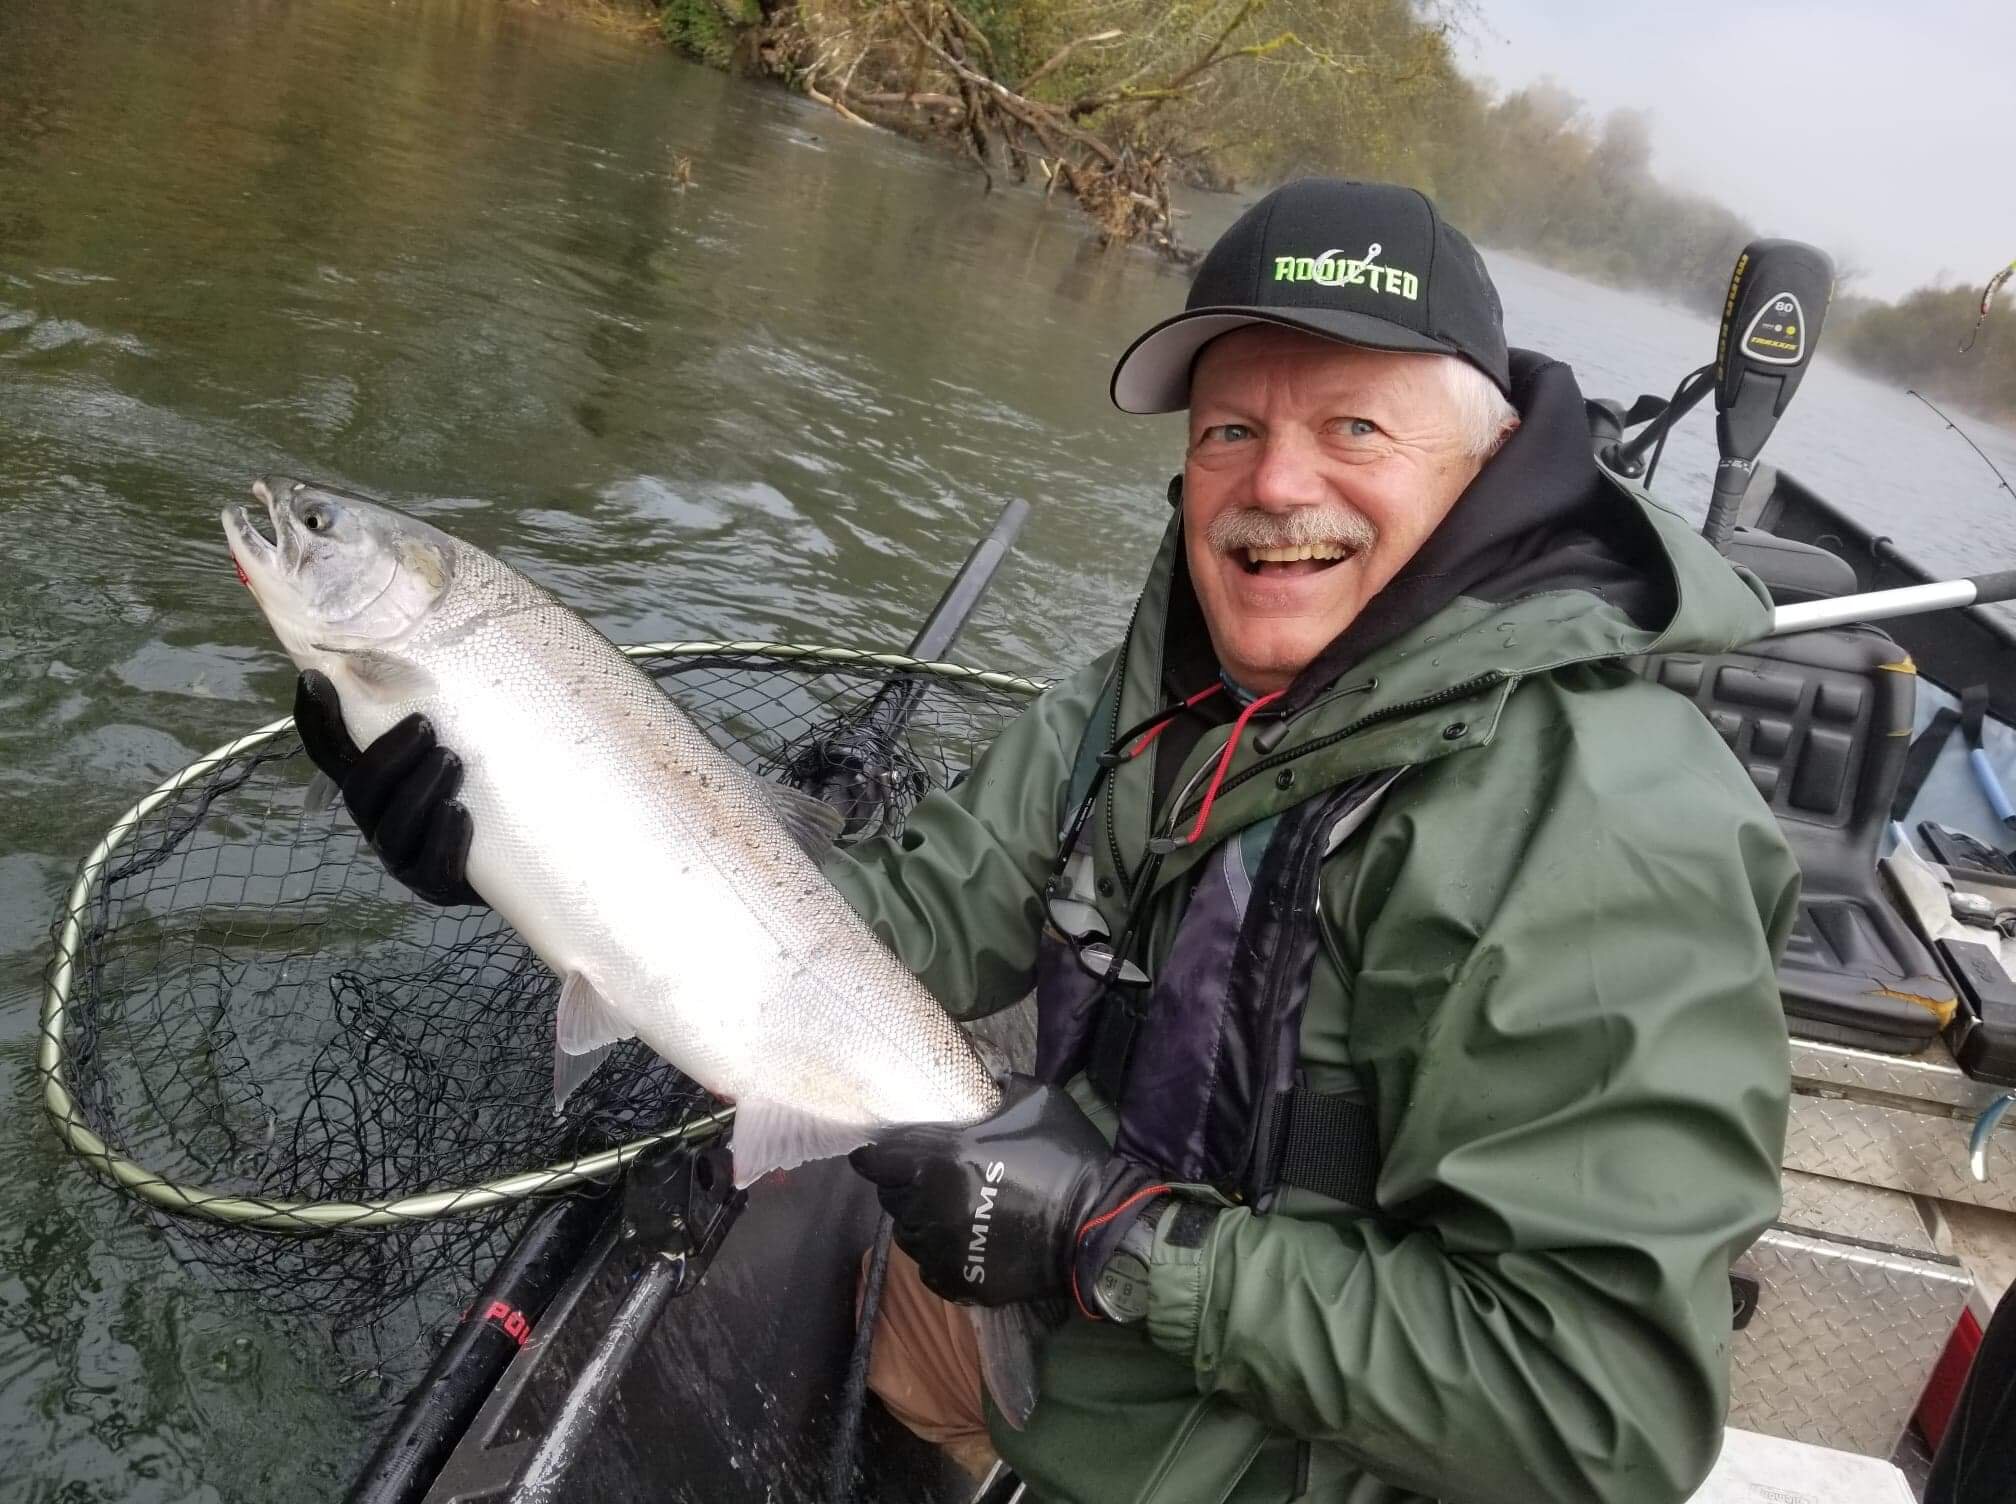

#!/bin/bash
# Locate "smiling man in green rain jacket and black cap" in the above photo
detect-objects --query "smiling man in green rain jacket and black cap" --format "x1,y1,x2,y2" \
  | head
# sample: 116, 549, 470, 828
298, 181, 1796, 1504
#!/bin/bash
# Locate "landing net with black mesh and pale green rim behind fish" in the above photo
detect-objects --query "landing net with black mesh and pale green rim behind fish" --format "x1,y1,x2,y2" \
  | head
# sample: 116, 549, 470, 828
42, 645, 1034, 1391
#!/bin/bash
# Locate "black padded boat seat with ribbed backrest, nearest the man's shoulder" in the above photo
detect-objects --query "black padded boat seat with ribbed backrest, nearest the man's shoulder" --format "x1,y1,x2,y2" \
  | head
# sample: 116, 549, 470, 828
1641, 616, 1956, 1054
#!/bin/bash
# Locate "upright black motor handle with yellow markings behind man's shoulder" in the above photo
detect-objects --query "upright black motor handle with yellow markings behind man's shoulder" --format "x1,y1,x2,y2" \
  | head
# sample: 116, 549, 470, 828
1702, 240, 1835, 548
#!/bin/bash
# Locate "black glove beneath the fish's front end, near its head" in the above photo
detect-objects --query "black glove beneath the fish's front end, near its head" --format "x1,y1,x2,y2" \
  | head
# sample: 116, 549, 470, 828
294, 669, 484, 903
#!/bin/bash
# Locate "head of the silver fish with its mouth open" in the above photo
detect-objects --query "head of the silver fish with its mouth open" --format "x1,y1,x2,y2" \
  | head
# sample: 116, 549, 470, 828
224, 476, 454, 671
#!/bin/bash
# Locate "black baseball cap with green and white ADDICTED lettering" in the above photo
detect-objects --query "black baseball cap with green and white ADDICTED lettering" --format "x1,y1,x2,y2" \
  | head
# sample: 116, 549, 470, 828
1113, 177, 1512, 413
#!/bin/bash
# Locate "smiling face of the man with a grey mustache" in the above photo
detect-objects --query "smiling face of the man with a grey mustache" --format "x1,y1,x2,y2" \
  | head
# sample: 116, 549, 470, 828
1183, 325, 1482, 694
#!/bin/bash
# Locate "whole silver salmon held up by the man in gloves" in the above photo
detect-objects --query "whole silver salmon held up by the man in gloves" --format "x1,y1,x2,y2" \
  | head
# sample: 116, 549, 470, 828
224, 476, 1036, 1421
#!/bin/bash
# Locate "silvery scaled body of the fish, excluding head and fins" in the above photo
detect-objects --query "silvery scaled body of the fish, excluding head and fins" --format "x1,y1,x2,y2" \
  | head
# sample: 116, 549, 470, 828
403, 548, 998, 1131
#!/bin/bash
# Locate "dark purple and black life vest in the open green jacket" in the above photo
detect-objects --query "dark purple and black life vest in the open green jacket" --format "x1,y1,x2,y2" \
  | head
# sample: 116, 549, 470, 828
1036, 696, 1397, 1210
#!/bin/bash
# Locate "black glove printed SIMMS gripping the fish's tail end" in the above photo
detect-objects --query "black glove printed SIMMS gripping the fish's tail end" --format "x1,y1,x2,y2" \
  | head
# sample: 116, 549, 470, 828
849, 1077, 1169, 1319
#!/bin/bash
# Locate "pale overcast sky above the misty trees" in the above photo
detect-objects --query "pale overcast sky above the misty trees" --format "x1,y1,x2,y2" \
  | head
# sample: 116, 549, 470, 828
1466, 0, 2016, 298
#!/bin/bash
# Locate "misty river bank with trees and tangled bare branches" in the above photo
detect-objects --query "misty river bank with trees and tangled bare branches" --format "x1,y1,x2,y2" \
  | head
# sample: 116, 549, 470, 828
568, 0, 2016, 425
